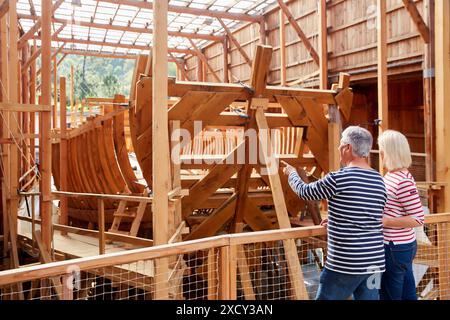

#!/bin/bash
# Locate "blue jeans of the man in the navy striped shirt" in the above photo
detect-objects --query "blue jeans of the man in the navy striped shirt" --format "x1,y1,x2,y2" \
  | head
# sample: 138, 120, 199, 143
316, 268, 381, 300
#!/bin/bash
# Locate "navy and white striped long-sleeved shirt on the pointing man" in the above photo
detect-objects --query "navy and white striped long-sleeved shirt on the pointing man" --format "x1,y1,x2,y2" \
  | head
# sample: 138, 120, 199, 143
289, 167, 387, 274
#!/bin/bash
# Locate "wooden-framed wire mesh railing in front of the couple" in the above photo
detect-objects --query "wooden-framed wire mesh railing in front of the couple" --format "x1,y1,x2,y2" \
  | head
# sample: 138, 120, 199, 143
0, 214, 450, 300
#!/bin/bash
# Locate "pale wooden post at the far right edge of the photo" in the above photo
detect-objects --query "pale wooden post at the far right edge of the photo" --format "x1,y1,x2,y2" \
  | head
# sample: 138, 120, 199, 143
435, 1, 450, 212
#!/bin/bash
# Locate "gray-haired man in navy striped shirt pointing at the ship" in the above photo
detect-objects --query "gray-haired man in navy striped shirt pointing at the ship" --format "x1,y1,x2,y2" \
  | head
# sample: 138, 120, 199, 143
284, 126, 386, 300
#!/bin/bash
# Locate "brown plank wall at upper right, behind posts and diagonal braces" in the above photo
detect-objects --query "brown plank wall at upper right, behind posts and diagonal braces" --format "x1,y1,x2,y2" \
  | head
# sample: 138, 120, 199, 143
186, 0, 425, 86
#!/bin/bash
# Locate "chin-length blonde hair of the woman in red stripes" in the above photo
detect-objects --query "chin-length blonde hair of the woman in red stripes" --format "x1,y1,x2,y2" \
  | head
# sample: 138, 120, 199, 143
378, 130, 412, 171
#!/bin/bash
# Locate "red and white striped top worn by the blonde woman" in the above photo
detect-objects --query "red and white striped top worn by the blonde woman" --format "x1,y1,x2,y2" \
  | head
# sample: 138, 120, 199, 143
383, 170, 424, 244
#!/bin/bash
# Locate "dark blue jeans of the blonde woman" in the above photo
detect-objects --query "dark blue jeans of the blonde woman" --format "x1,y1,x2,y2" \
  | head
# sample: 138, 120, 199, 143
380, 241, 417, 300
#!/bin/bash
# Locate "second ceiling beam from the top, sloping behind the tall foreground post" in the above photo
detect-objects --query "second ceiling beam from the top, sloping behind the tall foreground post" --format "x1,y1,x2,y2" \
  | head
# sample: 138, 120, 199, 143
18, 14, 224, 41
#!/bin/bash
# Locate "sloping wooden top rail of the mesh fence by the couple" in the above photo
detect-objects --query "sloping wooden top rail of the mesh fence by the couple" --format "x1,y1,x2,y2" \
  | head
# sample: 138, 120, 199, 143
0, 213, 450, 286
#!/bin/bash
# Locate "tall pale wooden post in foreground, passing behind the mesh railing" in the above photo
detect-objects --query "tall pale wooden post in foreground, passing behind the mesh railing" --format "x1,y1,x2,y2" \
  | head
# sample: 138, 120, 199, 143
152, 0, 170, 299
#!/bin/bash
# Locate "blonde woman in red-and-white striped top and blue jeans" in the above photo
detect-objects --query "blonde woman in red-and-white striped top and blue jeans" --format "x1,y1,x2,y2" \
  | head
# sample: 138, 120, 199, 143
378, 130, 424, 300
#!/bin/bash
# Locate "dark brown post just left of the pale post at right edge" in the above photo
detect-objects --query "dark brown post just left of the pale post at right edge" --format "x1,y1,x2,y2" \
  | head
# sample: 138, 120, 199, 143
423, 0, 436, 181
